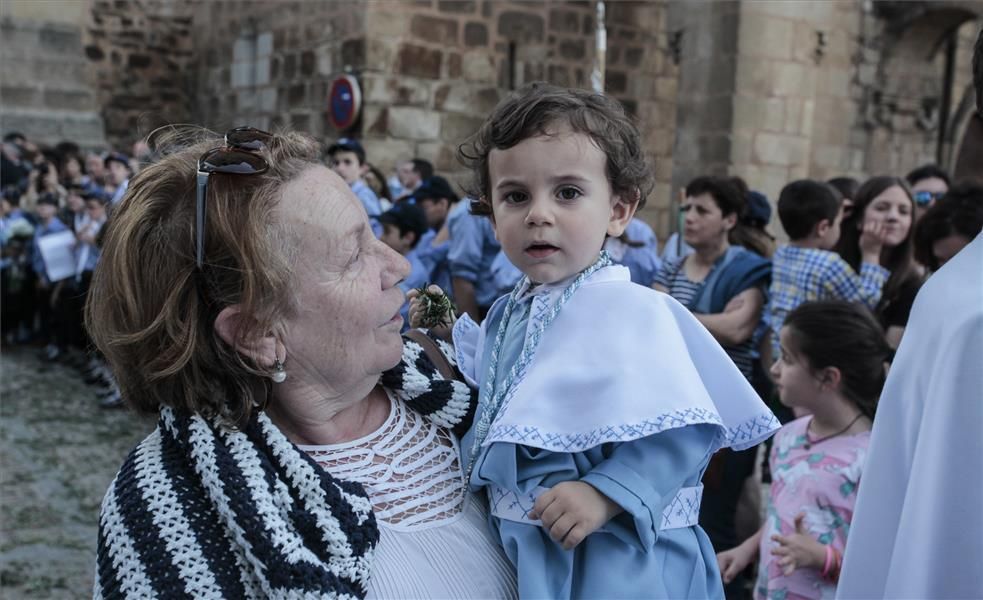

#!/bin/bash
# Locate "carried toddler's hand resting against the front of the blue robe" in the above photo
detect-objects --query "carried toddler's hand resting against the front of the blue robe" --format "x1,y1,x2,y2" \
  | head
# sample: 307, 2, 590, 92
529, 481, 624, 550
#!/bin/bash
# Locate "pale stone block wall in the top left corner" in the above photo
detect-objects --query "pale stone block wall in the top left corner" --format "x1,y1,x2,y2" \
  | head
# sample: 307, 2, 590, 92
0, 0, 105, 149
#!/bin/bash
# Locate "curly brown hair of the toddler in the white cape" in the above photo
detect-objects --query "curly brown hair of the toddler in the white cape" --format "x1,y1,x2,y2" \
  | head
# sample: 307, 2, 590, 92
457, 82, 655, 215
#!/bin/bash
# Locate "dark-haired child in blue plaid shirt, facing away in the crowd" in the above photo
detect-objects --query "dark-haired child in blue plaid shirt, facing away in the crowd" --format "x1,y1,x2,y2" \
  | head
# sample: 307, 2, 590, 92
765, 179, 891, 361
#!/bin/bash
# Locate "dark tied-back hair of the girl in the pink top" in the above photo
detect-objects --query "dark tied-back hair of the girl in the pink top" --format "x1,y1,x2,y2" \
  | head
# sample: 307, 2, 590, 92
784, 300, 892, 419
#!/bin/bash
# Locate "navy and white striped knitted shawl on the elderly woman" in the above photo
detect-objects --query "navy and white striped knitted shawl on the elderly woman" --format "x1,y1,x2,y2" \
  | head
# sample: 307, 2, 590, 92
94, 332, 476, 598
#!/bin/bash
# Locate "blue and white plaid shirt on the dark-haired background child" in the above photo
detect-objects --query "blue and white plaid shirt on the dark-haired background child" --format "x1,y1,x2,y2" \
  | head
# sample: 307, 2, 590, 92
765, 246, 891, 359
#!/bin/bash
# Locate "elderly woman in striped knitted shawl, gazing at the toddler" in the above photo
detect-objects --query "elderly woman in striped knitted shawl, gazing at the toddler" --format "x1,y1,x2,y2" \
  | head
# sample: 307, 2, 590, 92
86, 128, 515, 598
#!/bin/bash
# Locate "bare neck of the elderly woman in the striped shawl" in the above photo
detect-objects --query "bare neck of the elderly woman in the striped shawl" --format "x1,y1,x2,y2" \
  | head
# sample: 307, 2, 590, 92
266, 385, 390, 446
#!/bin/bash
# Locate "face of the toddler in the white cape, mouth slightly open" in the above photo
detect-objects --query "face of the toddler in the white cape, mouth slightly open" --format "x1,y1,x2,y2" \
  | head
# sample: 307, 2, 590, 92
488, 126, 637, 283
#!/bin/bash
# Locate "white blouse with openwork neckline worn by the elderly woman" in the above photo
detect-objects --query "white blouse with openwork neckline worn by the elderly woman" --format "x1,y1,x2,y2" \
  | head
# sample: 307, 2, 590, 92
300, 396, 517, 598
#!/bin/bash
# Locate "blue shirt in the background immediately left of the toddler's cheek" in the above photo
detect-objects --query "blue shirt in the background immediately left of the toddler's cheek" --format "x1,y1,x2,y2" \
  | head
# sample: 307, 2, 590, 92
447, 203, 502, 308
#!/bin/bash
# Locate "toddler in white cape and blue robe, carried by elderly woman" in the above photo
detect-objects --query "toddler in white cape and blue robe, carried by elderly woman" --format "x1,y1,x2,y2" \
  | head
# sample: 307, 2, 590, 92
411, 84, 778, 598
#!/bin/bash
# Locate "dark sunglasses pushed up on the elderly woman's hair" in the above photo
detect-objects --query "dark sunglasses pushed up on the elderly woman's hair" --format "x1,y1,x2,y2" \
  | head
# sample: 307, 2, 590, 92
195, 127, 273, 269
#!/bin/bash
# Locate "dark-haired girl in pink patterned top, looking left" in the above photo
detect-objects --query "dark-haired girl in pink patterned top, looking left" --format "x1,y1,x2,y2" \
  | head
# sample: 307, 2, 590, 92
717, 300, 890, 600
